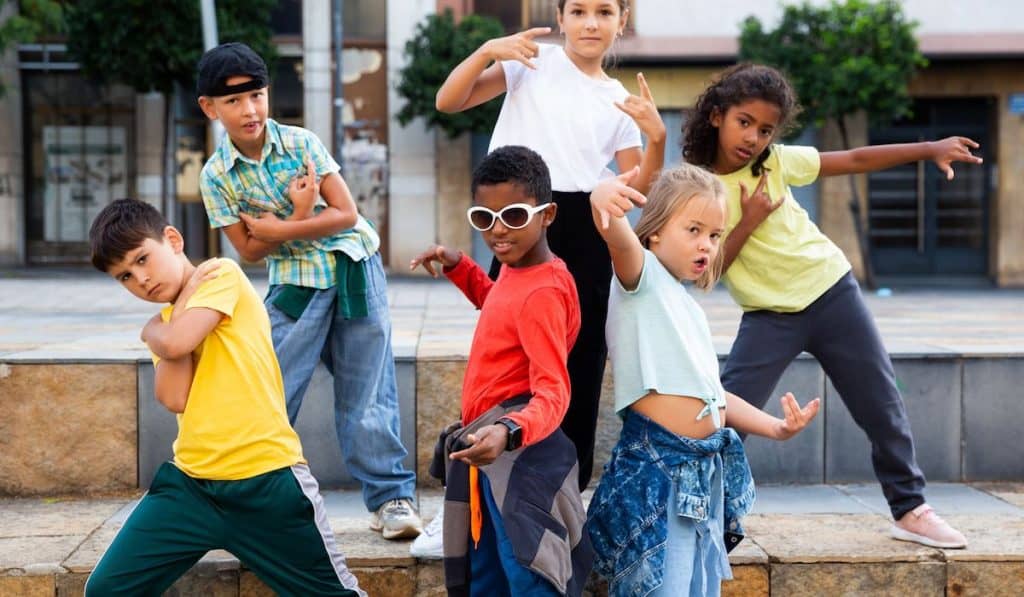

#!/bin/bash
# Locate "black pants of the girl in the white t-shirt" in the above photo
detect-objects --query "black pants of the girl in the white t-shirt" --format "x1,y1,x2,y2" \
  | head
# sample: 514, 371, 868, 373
489, 190, 611, 492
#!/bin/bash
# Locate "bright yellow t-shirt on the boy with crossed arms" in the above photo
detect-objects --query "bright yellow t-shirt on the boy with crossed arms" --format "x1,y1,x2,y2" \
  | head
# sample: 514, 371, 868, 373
154, 259, 305, 480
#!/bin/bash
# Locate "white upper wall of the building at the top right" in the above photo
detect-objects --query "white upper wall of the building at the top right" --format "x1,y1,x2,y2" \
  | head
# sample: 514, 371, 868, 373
632, 0, 1024, 37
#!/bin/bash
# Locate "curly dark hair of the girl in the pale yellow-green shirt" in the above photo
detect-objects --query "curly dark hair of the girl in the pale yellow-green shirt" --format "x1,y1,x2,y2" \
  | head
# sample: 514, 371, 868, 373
683, 62, 800, 176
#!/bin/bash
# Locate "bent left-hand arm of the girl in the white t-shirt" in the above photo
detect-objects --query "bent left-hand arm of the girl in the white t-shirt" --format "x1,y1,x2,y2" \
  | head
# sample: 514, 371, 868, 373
434, 27, 551, 114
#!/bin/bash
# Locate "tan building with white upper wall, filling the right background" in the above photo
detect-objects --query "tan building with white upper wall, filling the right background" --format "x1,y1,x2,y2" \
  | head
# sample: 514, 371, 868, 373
396, 0, 1024, 286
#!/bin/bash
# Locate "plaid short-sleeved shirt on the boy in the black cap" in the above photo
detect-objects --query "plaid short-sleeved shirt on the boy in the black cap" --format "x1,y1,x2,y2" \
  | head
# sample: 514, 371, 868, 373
200, 119, 380, 289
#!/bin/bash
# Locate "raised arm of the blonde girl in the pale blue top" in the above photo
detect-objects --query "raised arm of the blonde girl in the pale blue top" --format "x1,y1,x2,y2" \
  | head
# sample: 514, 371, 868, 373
590, 167, 647, 290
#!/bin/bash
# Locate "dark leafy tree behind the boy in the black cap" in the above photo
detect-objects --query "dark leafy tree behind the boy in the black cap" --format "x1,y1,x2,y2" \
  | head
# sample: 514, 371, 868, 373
66, 0, 278, 215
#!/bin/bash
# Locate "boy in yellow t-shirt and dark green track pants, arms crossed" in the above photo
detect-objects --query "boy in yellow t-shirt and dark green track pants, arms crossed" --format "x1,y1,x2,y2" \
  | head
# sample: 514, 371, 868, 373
85, 200, 366, 596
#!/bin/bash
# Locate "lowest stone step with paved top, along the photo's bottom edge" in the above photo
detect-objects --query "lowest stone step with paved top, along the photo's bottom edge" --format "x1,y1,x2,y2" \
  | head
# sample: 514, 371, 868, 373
0, 483, 1024, 597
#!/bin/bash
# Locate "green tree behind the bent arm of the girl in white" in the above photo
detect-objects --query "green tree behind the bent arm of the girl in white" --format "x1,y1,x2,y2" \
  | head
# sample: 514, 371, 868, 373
396, 8, 505, 138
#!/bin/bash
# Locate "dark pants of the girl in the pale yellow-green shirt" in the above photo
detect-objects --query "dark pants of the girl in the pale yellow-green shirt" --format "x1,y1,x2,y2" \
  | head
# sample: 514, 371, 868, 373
722, 273, 925, 519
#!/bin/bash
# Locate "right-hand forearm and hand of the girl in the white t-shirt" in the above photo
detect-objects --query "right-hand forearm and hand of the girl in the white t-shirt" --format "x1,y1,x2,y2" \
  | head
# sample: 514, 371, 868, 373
615, 73, 667, 194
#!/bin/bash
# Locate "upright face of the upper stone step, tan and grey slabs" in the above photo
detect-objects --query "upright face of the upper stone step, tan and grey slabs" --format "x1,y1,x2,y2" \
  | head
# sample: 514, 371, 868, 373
0, 353, 1024, 497
